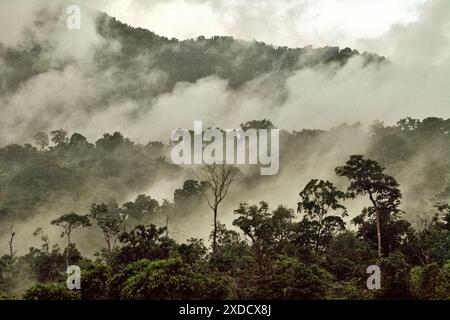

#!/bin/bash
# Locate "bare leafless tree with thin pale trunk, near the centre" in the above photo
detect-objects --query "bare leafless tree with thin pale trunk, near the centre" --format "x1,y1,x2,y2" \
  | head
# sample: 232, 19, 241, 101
198, 164, 234, 253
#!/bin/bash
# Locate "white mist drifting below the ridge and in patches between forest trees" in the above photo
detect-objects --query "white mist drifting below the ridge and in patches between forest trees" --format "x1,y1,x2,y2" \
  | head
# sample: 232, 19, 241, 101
0, 0, 450, 254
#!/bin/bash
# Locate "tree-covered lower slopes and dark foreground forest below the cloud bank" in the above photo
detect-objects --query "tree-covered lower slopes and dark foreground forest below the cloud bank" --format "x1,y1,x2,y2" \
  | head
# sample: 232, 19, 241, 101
0, 118, 450, 299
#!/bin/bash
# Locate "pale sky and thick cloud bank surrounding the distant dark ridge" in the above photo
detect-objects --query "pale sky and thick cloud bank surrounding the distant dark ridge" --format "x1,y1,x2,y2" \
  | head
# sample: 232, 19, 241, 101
0, 0, 450, 142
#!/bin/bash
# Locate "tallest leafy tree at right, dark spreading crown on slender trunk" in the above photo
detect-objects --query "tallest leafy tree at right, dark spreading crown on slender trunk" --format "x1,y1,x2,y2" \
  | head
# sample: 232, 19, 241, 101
335, 155, 402, 257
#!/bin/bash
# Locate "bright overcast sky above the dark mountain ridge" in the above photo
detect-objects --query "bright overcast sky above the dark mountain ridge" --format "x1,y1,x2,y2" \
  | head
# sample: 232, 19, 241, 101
92, 0, 429, 50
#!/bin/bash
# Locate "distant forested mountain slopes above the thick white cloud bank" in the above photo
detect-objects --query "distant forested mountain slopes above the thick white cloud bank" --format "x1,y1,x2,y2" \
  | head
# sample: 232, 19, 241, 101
0, 9, 385, 120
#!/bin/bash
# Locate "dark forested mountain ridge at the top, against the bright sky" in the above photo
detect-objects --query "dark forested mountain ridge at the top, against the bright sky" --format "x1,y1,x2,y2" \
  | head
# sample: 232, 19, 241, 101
96, 13, 386, 88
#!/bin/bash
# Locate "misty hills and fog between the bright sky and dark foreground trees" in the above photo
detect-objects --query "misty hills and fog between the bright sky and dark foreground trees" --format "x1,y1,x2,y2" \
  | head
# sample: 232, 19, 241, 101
0, 1, 450, 255
